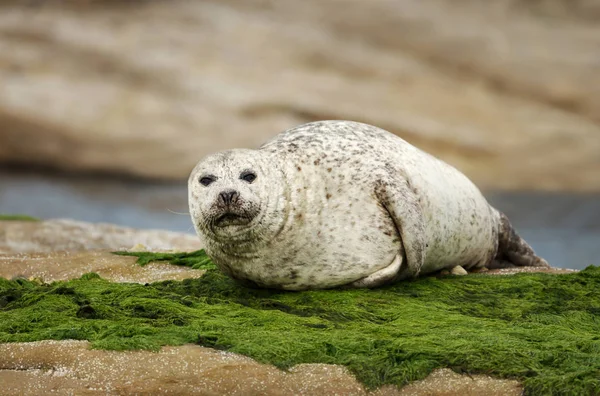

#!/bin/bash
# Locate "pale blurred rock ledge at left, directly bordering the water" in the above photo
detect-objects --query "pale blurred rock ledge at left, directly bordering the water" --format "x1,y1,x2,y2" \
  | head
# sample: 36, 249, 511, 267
0, 219, 201, 254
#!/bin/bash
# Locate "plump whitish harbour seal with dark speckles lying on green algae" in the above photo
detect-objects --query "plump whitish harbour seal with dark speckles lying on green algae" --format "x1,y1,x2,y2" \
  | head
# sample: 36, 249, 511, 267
188, 121, 548, 290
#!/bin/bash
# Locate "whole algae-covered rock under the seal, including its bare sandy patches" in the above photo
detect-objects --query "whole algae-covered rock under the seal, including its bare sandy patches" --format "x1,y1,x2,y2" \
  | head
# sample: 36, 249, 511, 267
0, 218, 600, 395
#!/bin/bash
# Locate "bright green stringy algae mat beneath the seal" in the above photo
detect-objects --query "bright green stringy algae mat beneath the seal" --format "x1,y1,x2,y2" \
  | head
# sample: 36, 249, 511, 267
0, 252, 600, 395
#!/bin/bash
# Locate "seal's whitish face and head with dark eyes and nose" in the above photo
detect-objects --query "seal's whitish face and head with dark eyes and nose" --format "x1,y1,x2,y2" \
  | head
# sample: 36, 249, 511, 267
188, 149, 278, 242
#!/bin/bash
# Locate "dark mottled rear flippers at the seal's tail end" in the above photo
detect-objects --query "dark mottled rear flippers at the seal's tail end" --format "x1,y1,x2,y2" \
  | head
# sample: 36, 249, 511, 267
488, 212, 550, 269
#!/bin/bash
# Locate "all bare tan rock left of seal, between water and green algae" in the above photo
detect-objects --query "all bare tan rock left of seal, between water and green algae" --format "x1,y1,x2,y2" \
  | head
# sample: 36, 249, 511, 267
0, 220, 204, 283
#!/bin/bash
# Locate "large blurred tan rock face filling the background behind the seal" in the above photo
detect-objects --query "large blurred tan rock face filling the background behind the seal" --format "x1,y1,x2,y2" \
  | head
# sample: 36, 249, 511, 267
0, 0, 600, 191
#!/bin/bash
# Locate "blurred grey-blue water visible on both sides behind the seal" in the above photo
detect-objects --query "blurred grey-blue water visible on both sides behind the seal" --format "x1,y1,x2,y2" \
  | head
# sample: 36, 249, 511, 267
0, 172, 600, 269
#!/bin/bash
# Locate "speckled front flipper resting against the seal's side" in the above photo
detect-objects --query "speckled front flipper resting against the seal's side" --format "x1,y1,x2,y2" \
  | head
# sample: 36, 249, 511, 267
375, 174, 427, 277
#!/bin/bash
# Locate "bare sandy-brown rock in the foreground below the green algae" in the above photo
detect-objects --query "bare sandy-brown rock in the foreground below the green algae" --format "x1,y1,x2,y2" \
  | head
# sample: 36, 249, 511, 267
0, 341, 522, 396
